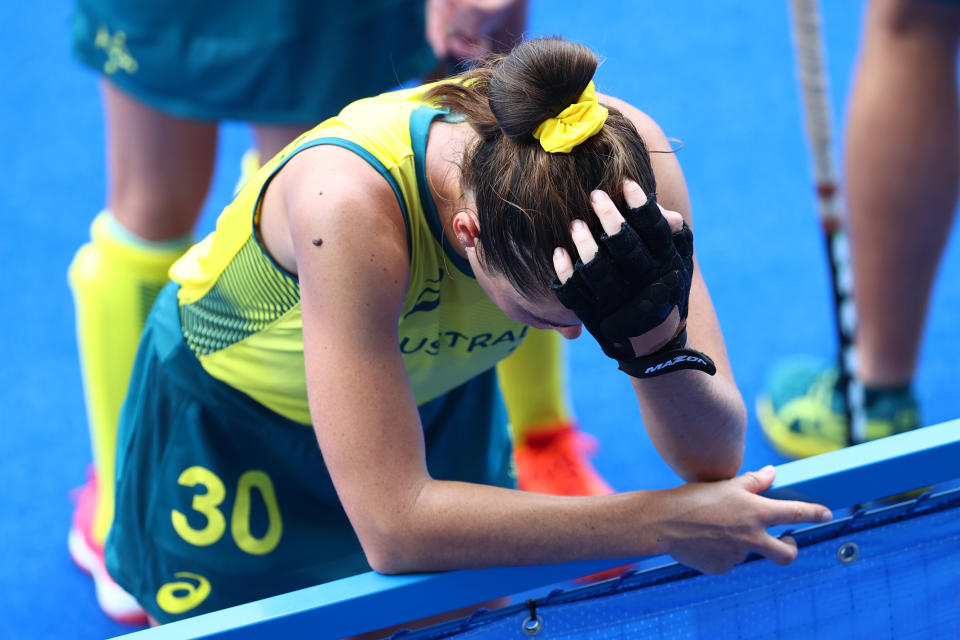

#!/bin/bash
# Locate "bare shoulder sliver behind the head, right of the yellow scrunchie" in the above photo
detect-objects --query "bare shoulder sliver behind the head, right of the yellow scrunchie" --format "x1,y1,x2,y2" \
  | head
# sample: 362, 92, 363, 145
599, 94, 692, 219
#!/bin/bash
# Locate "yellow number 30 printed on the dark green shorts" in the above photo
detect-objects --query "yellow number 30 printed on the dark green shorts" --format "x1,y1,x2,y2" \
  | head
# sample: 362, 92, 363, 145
170, 466, 283, 556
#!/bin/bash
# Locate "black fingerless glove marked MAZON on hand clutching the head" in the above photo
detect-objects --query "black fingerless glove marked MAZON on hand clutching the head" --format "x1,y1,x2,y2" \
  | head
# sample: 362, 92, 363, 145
551, 193, 717, 378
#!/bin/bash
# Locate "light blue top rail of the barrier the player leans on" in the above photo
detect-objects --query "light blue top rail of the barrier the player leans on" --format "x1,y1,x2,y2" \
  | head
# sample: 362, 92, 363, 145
123, 420, 960, 640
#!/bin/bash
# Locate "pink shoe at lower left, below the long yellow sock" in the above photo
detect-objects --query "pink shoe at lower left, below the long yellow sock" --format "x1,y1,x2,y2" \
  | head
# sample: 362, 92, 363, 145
67, 466, 147, 626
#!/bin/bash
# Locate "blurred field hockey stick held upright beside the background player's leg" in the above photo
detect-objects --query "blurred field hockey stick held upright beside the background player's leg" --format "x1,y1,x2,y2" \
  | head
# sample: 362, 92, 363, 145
790, 0, 866, 444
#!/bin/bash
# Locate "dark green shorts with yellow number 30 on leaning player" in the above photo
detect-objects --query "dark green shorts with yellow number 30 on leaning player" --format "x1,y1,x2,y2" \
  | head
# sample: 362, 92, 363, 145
106, 284, 514, 622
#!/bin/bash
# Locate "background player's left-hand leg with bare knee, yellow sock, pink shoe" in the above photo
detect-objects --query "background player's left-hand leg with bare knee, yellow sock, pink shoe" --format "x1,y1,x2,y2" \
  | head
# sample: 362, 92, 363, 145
68, 83, 217, 620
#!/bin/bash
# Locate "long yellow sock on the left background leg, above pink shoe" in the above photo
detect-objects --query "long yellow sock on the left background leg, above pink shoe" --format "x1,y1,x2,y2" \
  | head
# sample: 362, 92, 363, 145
67, 211, 191, 544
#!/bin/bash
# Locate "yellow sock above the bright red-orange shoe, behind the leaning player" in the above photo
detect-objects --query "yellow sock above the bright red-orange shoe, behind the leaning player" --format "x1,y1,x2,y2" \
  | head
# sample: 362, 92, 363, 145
497, 328, 569, 446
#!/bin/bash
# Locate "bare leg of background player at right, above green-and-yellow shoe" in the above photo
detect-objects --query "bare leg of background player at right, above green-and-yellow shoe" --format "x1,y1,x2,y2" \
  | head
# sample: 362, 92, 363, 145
845, 0, 960, 387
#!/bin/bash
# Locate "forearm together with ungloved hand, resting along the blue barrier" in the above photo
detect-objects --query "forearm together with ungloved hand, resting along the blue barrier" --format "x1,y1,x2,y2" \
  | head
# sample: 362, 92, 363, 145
361, 458, 830, 573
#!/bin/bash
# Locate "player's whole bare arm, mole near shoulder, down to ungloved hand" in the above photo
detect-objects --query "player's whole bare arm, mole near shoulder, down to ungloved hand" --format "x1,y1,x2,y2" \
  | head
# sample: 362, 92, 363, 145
285, 144, 824, 573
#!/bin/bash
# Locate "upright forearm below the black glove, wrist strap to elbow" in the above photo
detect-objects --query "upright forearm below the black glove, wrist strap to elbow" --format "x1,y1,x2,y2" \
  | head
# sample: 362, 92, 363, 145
631, 370, 747, 481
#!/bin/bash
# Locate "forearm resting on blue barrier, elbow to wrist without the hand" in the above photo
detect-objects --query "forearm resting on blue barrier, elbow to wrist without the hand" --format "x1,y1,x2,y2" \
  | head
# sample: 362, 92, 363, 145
363, 480, 666, 573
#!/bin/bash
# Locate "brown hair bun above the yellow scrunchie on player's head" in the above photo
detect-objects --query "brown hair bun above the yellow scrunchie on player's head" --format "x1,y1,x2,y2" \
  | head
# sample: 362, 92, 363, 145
489, 38, 598, 142
